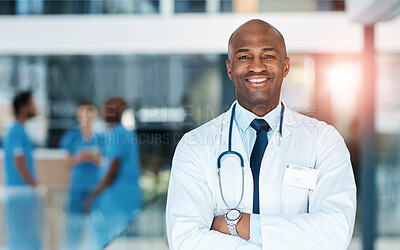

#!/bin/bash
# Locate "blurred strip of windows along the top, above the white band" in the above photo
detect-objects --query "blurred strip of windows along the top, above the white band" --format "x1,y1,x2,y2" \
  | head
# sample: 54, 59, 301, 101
0, 0, 345, 15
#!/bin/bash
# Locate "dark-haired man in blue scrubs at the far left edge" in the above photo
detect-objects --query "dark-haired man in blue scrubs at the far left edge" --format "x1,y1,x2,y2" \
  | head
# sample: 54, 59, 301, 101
4, 92, 42, 250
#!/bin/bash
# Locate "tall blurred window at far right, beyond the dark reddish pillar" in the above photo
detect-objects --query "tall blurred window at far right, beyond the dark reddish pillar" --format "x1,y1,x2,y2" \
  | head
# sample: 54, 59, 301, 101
375, 54, 400, 237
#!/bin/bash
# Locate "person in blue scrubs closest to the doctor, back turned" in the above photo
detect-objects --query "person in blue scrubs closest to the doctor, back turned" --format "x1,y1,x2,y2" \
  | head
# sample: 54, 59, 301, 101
85, 98, 143, 248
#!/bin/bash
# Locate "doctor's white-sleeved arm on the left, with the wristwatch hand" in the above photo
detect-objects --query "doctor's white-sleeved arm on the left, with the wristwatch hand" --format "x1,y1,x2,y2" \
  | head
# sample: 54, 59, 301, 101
166, 136, 260, 249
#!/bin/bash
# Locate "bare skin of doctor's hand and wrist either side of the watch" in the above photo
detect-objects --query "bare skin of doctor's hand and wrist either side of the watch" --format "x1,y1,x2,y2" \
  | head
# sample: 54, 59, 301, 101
211, 213, 250, 240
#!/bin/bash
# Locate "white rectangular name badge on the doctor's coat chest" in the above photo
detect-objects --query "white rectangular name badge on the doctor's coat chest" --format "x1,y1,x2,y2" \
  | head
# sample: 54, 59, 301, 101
283, 164, 319, 190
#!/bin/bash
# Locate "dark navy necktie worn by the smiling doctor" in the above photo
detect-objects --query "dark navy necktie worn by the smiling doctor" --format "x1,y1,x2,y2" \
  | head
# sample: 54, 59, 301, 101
250, 119, 270, 214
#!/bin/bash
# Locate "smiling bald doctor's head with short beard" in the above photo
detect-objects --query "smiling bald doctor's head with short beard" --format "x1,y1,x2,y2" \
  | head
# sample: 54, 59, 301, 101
226, 20, 290, 116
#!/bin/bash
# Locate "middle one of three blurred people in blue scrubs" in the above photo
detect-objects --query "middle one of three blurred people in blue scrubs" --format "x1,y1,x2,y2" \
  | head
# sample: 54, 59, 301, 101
60, 101, 101, 249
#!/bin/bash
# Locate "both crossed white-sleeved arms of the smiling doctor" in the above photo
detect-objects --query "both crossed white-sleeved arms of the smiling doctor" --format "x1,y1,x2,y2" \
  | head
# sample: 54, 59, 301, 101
166, 127, 356, 250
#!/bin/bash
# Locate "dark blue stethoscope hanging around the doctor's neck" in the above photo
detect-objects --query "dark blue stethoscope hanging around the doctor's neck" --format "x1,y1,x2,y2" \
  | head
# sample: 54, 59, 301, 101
217, 103, 285, 208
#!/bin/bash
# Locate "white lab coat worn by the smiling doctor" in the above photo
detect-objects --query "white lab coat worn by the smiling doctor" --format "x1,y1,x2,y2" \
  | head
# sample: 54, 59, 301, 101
166, 100, 356, 250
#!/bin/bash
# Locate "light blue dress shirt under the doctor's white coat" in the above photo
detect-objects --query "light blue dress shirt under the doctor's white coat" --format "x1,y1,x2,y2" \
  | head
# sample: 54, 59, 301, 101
235, 102, 282, 245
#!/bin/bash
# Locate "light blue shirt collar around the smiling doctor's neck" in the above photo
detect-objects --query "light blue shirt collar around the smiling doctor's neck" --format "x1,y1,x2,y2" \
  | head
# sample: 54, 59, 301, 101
235, 102, 282, 132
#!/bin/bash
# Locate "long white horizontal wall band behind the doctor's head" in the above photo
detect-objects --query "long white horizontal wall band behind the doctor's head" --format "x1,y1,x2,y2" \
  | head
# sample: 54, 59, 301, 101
0, 12, 364, 55
